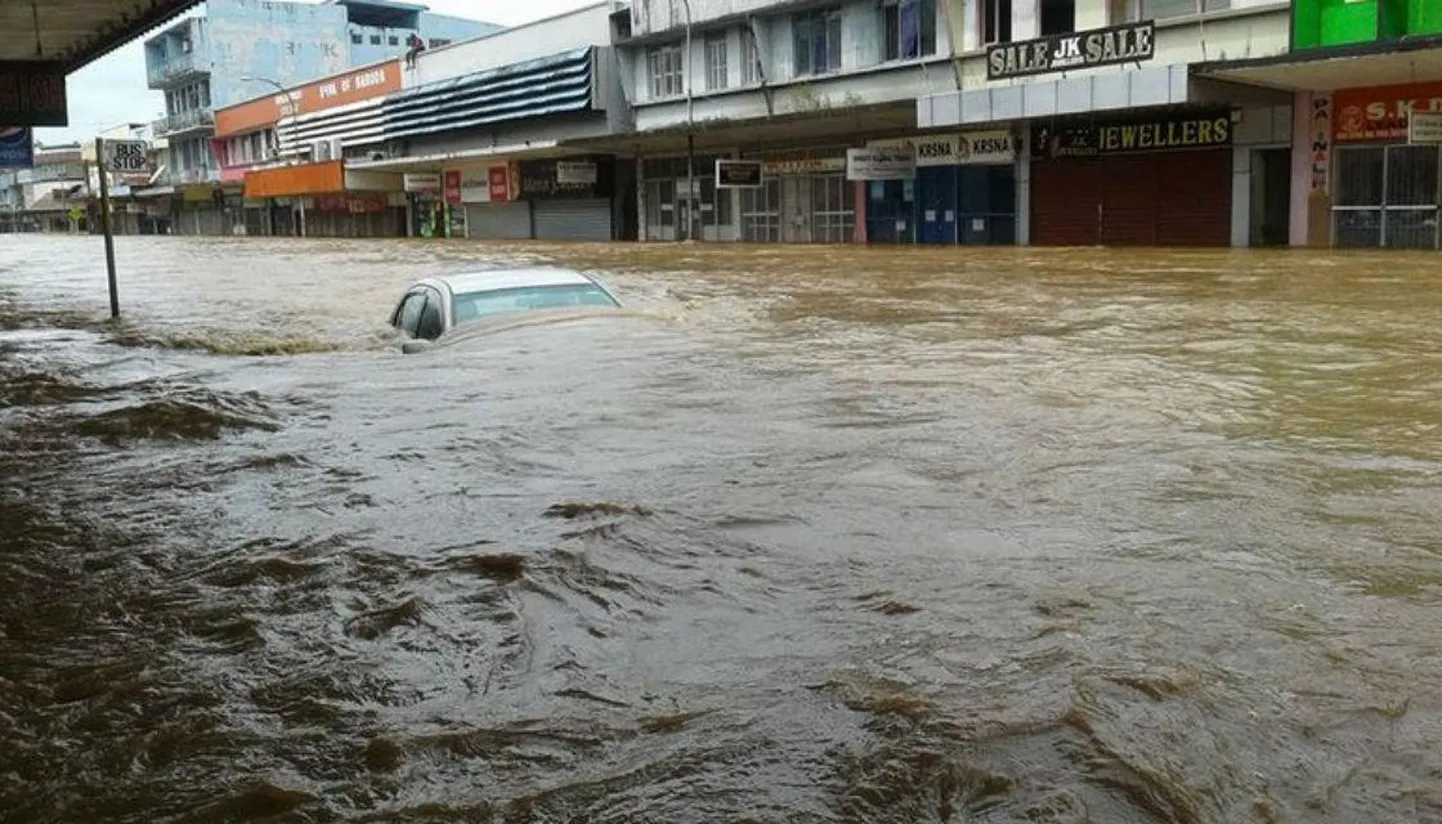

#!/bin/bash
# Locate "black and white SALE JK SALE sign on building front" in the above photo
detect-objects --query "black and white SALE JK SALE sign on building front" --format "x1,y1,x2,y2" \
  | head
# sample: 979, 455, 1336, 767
986, 20, 1156, 81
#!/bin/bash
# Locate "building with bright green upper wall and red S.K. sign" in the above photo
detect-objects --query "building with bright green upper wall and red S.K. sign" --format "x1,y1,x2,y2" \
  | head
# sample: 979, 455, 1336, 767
1203, 0, 1442, 248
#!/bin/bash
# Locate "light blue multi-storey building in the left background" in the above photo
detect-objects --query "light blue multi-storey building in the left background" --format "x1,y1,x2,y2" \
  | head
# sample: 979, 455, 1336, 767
146, 0, 497, 198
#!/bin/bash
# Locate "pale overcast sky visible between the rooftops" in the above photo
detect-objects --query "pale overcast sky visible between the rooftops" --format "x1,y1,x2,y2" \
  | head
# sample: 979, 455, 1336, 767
35, 0, 596, 146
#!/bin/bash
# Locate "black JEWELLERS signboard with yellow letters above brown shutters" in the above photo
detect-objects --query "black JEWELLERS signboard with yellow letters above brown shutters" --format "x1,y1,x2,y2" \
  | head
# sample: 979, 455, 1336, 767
1032, 111, 1231, 160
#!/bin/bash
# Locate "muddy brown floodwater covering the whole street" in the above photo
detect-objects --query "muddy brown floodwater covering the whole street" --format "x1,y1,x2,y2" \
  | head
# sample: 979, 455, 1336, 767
0, 235, 1442, 824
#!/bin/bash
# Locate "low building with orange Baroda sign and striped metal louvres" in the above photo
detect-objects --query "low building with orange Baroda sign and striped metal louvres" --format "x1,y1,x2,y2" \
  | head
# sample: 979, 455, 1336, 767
216, 3, 636, 240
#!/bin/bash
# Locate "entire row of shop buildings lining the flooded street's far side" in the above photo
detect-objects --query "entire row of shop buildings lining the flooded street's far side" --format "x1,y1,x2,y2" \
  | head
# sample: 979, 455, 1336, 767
22, 0, 1442, 248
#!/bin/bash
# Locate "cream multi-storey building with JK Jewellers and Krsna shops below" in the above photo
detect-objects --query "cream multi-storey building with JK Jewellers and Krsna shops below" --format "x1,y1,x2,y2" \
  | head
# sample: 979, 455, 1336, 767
608, 0, 1292, 245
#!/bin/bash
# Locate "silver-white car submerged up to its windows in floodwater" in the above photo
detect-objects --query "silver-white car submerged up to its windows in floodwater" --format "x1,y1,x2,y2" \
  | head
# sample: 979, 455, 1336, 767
391, 268, 622, 352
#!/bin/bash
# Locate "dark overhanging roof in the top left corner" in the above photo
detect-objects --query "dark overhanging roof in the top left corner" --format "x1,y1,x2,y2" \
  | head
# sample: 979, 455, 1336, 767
0, 0, 200, 72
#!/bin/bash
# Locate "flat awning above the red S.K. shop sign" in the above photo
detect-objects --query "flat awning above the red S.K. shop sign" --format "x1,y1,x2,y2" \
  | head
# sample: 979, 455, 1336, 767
1193, 36, 1442, 91
